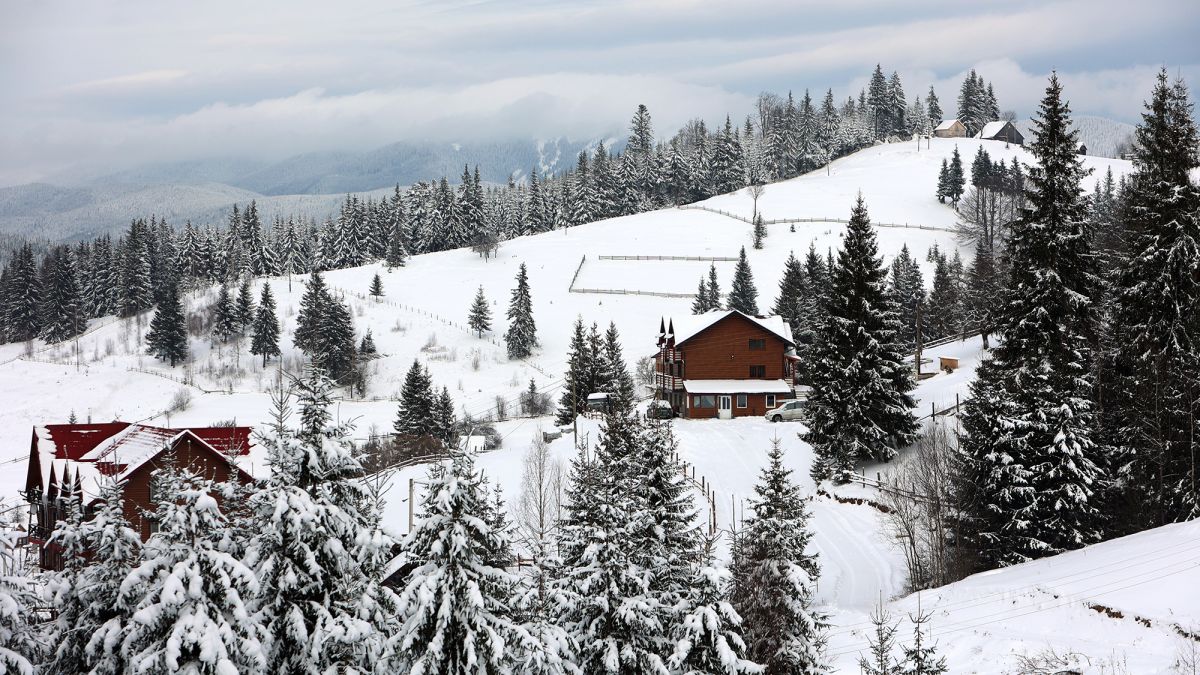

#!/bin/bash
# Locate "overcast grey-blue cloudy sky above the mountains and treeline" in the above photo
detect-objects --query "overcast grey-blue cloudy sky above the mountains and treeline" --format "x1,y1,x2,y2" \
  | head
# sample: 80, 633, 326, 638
0, 0, 1200, 185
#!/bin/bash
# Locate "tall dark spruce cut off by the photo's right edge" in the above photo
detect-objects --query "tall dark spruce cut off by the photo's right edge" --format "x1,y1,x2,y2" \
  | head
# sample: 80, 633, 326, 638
1104, 70, 1200, 528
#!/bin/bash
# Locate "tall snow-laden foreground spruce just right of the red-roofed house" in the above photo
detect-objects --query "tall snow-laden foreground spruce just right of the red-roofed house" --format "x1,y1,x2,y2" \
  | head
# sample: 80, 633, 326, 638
246, 368, 390, 675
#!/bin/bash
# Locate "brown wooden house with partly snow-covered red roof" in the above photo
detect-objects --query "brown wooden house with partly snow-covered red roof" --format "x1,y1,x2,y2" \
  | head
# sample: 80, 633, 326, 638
24, 422, 266, 569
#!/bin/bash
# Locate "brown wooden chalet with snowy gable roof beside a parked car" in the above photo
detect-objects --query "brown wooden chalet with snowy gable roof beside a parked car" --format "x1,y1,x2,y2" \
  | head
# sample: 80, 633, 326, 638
654, 310, 797, 419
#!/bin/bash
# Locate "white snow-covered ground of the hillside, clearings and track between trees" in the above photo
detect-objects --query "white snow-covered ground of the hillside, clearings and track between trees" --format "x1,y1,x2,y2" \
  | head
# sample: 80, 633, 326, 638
7, 139, 1200, 673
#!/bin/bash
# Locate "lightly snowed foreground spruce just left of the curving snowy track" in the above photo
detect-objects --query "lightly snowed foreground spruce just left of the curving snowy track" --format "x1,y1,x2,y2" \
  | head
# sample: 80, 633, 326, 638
730, 440, 826, 673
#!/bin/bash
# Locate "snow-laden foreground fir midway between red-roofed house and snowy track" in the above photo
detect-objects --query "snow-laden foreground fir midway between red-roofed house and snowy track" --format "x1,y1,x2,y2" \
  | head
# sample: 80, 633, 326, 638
388, 444, 528, 675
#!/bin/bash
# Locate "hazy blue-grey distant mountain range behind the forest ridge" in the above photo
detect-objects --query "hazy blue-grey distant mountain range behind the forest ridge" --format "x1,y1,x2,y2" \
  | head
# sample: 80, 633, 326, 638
0, 138, 608, 239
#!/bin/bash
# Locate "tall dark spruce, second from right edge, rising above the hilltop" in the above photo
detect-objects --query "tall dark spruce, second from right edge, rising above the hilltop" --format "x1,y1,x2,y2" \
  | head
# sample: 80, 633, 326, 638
960, 74, 1103, 566
